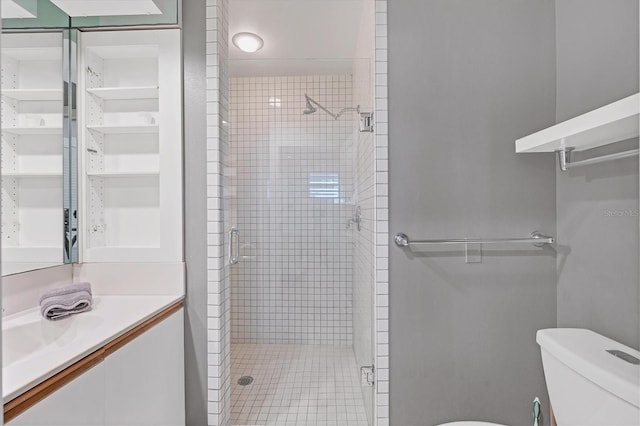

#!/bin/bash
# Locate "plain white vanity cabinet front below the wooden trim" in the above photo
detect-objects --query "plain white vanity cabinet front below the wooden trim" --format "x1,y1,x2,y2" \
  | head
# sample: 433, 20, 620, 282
7, 309, 185, 426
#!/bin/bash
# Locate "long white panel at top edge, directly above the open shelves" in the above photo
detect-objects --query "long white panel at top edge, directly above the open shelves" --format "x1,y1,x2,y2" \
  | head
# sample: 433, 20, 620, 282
51, 0, 162, 17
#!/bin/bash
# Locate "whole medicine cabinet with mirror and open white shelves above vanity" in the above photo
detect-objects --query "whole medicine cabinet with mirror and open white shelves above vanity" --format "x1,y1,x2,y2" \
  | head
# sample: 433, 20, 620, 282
0, 0, 182, 276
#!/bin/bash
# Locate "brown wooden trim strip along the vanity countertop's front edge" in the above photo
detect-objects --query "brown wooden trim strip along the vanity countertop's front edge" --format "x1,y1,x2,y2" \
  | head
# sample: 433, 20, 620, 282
4, 300, 184, 422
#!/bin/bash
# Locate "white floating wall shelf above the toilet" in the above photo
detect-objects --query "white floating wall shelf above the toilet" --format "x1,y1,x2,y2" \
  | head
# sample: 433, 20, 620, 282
516, 93, 640, 153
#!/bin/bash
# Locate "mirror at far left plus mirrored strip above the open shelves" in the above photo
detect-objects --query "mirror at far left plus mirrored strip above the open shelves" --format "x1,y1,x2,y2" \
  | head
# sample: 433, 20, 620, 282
0, 0, 180, 276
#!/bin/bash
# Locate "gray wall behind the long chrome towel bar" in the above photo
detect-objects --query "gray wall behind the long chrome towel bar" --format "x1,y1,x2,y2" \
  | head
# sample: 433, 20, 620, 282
389, 0, 556, 426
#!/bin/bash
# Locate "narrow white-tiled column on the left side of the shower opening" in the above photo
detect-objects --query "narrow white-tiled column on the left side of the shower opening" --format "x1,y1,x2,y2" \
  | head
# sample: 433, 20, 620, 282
206, 0, 231, 426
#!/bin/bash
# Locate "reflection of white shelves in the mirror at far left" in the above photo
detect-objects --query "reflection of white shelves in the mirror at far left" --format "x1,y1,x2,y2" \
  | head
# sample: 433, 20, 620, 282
0, 32, 63, 274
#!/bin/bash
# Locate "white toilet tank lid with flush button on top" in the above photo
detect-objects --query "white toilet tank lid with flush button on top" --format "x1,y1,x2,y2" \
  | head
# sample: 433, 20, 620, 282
536, 328, 640, 407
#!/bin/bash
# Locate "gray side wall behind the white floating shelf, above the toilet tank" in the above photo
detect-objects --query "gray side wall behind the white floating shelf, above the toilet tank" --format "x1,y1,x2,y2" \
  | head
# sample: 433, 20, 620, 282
556, 0, 639, 347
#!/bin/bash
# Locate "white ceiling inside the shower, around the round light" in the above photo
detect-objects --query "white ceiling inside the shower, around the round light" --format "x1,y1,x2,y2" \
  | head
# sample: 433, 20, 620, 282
229, 0, 373, 76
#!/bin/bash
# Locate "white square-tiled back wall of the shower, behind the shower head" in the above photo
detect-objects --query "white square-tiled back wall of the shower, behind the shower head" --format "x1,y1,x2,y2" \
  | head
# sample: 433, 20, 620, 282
231, 75, 357, 344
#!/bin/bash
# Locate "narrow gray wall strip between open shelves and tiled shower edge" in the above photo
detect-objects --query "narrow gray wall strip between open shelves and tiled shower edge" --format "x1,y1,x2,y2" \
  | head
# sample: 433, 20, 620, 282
182, 0, 207, 426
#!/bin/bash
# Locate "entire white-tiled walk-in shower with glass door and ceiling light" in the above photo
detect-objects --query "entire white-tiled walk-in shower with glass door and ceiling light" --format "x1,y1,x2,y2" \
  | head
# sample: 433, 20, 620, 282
202, 0, 389, 426
